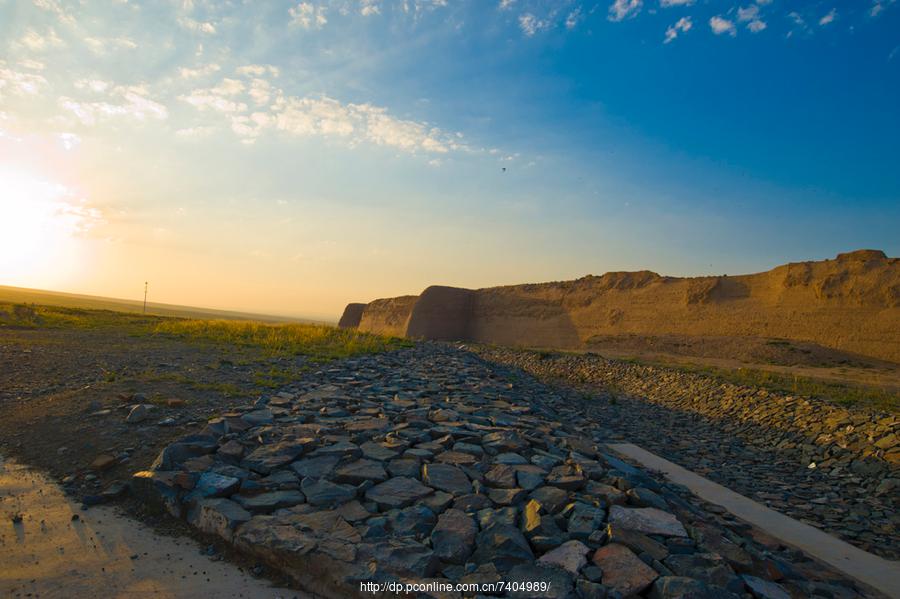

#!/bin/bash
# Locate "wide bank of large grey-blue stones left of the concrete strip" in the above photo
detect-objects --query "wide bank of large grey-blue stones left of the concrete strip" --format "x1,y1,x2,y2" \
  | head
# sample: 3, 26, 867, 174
132, 344, 884, 598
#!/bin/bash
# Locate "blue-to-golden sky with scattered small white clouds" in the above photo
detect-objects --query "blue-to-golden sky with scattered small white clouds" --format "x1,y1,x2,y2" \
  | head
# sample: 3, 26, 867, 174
0, 0, 900, 319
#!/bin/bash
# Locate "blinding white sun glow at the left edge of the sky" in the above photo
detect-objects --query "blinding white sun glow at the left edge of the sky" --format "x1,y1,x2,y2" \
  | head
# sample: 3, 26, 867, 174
0, 169, 101, 284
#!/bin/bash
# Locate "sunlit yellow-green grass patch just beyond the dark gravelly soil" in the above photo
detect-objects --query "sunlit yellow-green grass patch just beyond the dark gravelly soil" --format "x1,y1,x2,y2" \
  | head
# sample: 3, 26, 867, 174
154, 320, 411, 360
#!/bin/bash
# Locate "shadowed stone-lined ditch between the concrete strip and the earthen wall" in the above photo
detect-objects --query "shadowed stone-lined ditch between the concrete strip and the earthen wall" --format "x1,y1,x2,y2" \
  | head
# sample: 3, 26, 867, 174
474, 348, 900, 560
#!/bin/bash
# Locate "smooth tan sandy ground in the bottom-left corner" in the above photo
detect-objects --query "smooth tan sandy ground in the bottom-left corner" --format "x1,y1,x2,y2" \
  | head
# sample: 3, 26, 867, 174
0, 459, 309, 599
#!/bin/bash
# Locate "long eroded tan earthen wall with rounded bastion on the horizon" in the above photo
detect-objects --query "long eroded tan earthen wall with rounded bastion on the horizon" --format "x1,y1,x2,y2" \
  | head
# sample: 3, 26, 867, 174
347, 250, 900, 362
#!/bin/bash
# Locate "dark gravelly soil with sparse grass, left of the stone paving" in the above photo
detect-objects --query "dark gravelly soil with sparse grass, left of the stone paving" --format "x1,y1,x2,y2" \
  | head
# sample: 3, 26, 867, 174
0, 328, 307, 492
